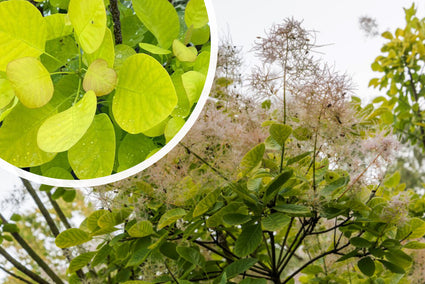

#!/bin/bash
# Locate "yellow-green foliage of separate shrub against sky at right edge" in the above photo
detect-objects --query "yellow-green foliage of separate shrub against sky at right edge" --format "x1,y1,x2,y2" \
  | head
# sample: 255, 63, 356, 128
369, 5, 425, 152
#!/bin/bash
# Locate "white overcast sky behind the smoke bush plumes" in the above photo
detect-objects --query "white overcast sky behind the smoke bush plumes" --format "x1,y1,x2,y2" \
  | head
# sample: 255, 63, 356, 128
0, 0, 425, 200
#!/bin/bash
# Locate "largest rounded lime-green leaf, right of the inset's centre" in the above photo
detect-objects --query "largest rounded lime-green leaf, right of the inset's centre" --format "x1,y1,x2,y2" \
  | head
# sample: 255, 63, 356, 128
112, 54, 177, 134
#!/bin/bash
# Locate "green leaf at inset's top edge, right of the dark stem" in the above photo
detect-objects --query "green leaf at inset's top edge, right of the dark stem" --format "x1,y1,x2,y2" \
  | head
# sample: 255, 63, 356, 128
132, 0, 180, 49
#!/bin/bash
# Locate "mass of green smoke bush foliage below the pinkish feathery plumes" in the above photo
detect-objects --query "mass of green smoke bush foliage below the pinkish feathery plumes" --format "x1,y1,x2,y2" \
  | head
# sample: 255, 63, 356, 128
56, 113, 425, 283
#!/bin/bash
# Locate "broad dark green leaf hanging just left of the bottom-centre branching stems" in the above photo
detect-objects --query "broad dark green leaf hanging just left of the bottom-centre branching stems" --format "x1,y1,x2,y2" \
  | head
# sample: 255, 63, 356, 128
234, 223, 263, 257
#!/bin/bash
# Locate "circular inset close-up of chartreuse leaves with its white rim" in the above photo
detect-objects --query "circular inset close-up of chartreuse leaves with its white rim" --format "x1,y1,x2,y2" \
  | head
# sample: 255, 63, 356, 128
0, 0, 217, 187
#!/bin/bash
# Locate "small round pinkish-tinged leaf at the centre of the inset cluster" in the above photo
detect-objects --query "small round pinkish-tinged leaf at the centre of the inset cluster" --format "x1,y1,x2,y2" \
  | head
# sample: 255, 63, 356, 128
83, 59, 117, 97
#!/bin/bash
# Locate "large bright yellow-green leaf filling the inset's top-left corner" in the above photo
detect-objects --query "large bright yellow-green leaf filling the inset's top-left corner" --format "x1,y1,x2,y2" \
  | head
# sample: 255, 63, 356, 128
0, 1, 47, 71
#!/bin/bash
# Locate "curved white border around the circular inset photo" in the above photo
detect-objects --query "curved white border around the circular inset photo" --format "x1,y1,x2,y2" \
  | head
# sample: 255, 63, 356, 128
0, 0, 218, 188
